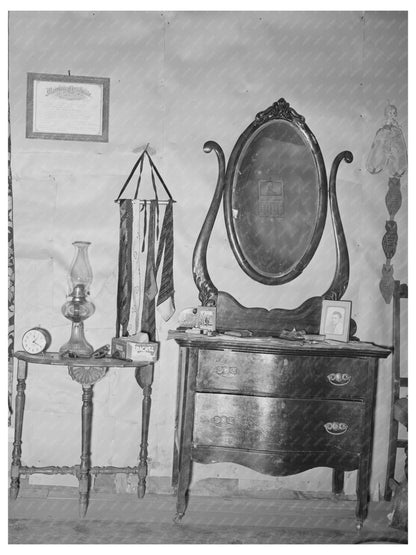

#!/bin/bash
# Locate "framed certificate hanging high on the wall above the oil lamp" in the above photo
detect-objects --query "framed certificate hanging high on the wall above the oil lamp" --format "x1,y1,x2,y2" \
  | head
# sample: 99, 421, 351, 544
26, 73, 110, 142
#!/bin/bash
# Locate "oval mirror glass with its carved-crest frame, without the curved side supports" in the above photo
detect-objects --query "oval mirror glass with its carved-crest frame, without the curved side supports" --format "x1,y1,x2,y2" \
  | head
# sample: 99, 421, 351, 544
224, 99, 327, 285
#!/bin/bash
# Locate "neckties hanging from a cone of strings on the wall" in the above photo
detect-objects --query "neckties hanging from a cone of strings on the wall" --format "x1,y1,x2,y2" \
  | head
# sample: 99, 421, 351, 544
116, 146, 175, 341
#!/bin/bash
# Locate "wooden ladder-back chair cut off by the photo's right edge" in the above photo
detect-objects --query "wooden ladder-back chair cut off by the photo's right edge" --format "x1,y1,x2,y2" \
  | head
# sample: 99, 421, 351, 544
384, 280, 408, 501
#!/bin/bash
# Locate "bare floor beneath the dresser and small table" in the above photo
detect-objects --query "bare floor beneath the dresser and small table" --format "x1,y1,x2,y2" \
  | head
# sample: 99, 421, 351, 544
9, 486, 407, 544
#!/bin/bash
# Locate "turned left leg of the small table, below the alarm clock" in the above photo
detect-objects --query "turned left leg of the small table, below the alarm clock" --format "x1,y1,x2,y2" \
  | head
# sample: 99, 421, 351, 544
10, 360, 27, 500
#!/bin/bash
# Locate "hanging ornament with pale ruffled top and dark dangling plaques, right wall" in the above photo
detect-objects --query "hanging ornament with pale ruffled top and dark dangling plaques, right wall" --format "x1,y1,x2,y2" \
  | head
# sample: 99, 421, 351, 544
367, 103, 407, 304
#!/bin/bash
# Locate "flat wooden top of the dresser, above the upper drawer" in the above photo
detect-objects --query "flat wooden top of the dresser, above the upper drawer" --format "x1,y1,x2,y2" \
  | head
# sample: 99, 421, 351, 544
168, 330, 391, 358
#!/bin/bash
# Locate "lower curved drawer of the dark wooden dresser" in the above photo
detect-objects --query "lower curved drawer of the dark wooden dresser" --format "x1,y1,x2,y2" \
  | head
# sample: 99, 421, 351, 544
193, 393, 364, 453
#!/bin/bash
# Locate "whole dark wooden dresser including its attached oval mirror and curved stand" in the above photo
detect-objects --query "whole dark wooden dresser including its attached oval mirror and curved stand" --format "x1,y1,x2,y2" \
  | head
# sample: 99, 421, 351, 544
171, 98, 389, 527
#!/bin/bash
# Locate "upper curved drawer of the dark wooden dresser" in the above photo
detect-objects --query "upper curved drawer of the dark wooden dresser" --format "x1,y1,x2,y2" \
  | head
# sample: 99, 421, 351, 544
197, 350, 368, 399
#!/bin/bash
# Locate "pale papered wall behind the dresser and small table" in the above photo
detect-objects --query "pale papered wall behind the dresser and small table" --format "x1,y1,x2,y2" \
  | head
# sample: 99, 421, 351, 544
9, 12, 407, 495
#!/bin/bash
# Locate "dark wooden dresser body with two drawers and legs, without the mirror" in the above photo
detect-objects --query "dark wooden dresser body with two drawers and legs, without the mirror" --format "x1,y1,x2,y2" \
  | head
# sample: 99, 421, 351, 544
170, 331, 390, 528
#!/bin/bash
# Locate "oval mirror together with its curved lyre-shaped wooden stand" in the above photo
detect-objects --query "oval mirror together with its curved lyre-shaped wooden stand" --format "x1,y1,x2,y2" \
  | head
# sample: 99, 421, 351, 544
193, 98, 352, 334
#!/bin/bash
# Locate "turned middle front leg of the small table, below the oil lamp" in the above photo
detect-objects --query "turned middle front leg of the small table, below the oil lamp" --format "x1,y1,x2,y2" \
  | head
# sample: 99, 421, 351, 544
78, 385, 93, 518
